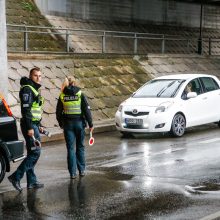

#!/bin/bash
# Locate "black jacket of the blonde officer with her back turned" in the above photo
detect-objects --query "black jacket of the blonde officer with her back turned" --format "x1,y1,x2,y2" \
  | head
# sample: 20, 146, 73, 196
56, 86, 93, 128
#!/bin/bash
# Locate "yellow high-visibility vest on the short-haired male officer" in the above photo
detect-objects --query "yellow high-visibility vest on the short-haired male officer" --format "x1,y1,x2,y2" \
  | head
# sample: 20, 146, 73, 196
22, 85, 44, 121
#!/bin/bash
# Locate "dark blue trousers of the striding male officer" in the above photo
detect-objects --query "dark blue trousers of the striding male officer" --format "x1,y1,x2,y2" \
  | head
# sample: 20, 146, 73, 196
12, 120, 41, 186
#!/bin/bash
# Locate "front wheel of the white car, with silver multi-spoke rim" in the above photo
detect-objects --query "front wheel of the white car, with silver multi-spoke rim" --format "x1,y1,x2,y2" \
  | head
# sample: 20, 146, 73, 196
170, 113, 186, 137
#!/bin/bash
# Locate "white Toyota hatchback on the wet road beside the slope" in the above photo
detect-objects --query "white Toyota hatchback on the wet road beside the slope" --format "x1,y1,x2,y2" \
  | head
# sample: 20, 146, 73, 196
115, 74, 220, 137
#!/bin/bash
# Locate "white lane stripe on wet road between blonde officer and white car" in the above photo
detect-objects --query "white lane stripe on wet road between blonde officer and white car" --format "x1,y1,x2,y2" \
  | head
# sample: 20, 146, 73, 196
101, 148, 185, 167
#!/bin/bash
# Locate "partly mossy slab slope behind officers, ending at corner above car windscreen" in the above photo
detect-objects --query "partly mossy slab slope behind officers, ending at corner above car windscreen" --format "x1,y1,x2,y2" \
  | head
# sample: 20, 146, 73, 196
8, 56, 149, 128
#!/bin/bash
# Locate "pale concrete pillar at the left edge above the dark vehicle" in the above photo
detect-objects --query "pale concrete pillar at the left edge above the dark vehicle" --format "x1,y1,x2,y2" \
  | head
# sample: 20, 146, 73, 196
0, 0, 8, 99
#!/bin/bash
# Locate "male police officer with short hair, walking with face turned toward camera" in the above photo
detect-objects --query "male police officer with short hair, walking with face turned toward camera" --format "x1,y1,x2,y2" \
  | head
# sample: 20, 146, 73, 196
8, 67, 44, 192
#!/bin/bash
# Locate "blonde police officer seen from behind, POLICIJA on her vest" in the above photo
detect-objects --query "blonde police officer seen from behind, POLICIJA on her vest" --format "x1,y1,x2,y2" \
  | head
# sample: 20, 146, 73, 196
56, 78, 93, 179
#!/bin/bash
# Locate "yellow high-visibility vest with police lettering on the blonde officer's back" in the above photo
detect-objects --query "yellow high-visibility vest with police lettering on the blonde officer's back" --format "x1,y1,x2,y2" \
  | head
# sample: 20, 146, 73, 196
60, 90, 82, 115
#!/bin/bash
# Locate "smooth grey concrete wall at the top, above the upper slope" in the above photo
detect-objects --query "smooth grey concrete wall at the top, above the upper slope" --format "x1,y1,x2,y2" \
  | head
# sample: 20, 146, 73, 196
35, 0, 220, 28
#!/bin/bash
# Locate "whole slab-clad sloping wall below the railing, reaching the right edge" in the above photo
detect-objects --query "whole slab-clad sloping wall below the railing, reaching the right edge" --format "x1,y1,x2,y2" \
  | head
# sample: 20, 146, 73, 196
8, 54, 220, 138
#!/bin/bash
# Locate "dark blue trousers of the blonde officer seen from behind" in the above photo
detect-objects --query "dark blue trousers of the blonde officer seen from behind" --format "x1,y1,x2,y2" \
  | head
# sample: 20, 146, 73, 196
63, 119, 85, 176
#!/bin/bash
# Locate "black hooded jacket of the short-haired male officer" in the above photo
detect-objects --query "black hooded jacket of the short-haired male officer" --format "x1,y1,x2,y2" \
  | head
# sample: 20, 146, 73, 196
19, 77, 41, 130
